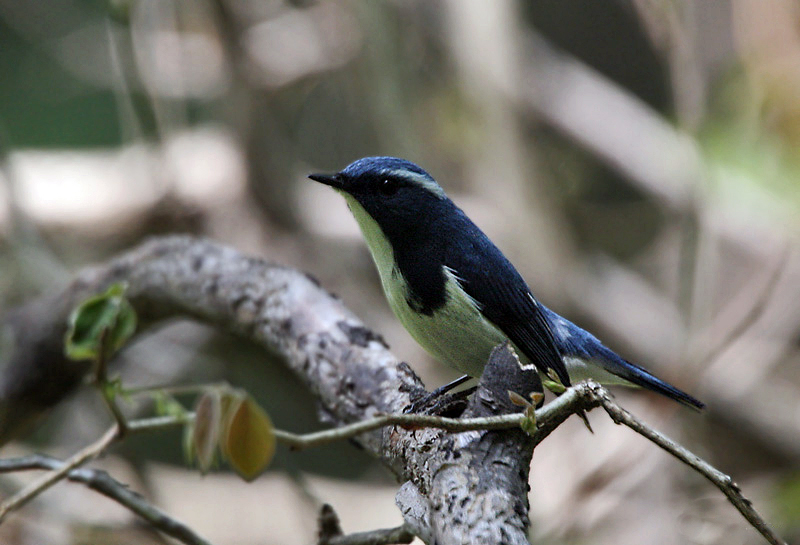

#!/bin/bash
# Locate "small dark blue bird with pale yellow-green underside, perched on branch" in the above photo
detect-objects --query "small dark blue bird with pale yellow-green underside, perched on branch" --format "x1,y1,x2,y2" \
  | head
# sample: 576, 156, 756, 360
308, 156, 704, 410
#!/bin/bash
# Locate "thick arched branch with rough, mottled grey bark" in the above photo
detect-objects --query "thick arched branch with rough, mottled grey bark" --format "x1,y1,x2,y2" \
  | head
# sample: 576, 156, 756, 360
0, 237, 532, 545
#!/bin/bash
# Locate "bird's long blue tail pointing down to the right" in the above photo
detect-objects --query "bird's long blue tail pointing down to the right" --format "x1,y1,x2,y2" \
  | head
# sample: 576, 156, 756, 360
542, 306, 705, 409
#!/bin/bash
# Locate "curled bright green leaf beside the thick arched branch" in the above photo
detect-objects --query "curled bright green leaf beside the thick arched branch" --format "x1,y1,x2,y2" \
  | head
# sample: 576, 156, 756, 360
64, 283, 136, 360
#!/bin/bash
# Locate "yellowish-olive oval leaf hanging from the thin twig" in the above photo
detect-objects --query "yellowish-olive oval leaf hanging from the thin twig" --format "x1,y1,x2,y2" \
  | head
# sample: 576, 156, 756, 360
222, 396, 275, 481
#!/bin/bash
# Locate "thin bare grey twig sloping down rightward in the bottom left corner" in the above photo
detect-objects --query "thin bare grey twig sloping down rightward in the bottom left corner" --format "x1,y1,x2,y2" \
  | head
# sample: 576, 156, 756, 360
0, 455, 211, 545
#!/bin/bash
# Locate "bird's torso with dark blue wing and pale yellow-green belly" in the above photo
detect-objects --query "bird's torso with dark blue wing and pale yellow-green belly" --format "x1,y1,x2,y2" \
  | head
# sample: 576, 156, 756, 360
384, 198, 570, 385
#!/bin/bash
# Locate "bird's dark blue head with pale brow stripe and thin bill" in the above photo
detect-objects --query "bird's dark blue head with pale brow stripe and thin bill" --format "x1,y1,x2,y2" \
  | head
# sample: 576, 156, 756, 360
309, 157, 448, 230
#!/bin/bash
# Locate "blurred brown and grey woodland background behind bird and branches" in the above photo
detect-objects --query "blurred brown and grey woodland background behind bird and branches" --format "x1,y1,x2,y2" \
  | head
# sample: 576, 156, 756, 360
0, 0, 800, 545
